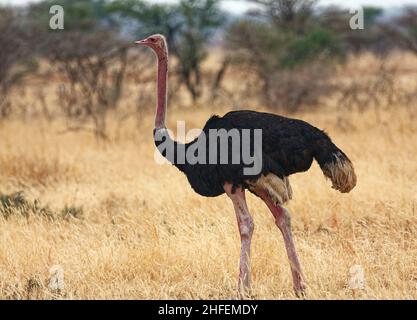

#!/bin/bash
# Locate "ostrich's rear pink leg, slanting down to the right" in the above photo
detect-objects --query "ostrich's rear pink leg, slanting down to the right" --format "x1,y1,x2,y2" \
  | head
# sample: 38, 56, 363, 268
257, 192, 306, 297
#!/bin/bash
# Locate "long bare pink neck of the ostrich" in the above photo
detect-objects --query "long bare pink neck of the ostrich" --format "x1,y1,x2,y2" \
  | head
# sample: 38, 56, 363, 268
155, 52, 168, 129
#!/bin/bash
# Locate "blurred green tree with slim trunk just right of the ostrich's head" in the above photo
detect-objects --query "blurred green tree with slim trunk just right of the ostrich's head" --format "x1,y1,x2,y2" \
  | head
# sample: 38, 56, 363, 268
108, 0, 225, 101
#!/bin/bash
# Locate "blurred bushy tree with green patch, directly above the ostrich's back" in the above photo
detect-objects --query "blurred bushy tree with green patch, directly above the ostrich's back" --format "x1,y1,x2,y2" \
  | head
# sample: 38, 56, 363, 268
227, 0, 343, 111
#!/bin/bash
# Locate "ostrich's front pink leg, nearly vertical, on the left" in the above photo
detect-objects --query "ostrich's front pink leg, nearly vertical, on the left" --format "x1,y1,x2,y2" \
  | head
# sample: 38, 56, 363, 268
224, 183, 254, 298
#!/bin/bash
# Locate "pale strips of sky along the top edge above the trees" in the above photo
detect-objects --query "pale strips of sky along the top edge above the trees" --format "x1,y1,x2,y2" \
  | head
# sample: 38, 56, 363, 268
0, 0, 417, 14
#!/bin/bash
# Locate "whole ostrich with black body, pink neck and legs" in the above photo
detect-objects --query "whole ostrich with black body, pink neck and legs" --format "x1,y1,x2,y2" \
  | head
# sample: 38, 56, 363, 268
136, 34, 356, 297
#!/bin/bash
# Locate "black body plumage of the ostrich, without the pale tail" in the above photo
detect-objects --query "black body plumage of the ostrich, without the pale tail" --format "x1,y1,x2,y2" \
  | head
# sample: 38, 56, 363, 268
155, 110, 356, 197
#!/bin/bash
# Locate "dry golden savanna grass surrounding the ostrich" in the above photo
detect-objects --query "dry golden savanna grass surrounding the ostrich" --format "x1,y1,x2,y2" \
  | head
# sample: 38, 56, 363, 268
0, 53, 417, 299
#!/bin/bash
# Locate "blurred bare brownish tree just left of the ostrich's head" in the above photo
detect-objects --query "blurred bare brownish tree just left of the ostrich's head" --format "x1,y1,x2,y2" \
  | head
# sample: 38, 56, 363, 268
30, 0, 128, 139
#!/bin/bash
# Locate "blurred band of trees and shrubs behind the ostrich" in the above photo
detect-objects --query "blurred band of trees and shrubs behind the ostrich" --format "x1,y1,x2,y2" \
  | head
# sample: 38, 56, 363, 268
0, 0, 417, 139
